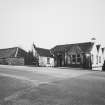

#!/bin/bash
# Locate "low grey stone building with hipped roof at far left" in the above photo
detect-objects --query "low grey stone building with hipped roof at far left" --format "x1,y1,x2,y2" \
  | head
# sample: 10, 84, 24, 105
0, 47, 27, 65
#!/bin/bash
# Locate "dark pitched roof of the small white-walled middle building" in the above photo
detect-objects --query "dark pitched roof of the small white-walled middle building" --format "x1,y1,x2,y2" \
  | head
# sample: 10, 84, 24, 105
35, 47, 53, 57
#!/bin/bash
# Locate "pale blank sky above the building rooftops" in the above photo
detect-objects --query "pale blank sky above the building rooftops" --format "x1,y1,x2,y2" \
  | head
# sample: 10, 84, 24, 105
0, 0, 105, 50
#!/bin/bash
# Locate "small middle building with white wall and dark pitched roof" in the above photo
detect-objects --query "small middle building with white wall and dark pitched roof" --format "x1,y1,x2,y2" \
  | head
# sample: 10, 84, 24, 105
32, 44, 54, 67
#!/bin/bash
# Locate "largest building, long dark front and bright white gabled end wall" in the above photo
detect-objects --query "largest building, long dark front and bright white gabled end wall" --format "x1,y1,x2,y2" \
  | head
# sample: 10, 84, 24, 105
51, 41, 105, 70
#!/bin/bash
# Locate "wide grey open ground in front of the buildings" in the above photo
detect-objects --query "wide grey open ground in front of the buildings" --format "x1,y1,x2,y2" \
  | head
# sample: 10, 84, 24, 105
0, 65, 105, 105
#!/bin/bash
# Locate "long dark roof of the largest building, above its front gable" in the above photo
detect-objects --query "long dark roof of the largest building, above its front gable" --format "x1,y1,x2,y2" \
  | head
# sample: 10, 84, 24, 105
51, 42, 94, 53
